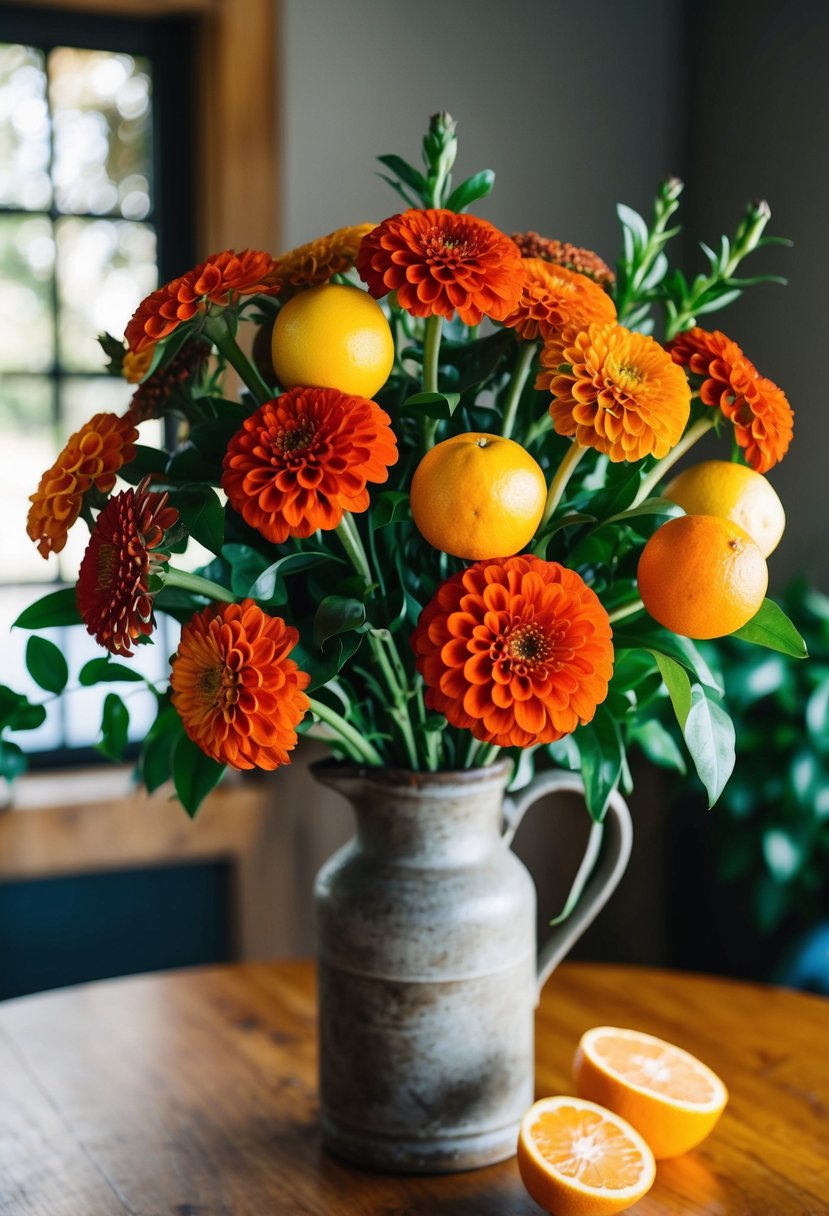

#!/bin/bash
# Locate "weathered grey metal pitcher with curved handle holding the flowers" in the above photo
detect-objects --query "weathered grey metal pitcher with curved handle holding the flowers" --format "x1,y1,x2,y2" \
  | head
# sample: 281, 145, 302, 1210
312, 761, 631, 1172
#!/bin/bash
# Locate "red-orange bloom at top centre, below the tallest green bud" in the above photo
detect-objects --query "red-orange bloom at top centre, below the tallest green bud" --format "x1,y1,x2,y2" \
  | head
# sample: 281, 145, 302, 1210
356, 208, 524, 325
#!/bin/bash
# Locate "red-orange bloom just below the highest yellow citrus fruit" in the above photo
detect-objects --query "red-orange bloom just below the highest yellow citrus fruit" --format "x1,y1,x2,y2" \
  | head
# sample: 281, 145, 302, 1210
221, 387, 397, 545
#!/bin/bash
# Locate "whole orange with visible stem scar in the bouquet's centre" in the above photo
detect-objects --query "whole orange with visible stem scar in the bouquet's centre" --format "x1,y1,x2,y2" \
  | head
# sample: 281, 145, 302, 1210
410, 430, 547, 561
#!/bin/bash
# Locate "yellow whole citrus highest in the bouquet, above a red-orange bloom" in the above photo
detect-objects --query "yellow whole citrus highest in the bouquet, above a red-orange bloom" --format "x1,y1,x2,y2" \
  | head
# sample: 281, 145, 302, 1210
271, 283, 394, 398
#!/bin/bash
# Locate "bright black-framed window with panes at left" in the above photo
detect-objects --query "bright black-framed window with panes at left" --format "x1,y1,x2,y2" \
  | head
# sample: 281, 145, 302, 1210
0, 9, 196, 754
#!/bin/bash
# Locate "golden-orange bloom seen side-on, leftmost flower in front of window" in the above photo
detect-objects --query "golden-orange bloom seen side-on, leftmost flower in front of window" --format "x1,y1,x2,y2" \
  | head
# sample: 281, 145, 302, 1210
26, 413, 139, 557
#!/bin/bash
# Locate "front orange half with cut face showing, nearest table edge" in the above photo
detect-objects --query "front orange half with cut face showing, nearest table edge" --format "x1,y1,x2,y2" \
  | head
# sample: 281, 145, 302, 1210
518, 1097, 656, 1216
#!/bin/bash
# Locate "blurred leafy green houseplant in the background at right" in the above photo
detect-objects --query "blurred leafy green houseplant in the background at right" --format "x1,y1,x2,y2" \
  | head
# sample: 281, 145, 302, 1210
672, 579, 829, 991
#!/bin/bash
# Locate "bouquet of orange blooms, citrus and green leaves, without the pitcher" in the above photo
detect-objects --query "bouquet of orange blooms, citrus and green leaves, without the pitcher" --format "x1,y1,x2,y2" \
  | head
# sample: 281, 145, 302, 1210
2, 114, 803, 820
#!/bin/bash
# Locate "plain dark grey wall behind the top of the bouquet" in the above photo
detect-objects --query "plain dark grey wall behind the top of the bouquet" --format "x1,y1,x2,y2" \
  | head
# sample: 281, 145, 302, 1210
281, 0, 829, 590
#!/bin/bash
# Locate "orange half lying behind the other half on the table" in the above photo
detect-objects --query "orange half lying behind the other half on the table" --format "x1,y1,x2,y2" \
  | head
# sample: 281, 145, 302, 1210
573, 1026, 728, 1161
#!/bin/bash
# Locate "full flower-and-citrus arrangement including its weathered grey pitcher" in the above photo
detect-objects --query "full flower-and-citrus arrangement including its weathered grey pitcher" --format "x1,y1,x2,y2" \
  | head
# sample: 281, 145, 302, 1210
0, 114, 805, 1171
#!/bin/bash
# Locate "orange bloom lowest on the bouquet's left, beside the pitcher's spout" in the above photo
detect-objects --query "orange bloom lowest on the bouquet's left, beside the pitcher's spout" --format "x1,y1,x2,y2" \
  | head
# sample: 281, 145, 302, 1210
170, 599, 310, 770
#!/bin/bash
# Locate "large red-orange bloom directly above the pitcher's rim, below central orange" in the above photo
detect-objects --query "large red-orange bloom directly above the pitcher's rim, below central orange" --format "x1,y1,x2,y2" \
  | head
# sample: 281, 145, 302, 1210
412, 554, 613, 748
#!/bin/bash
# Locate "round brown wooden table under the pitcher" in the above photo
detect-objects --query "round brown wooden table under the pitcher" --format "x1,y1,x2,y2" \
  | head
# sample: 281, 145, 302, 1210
0, 962, 829, 1216
